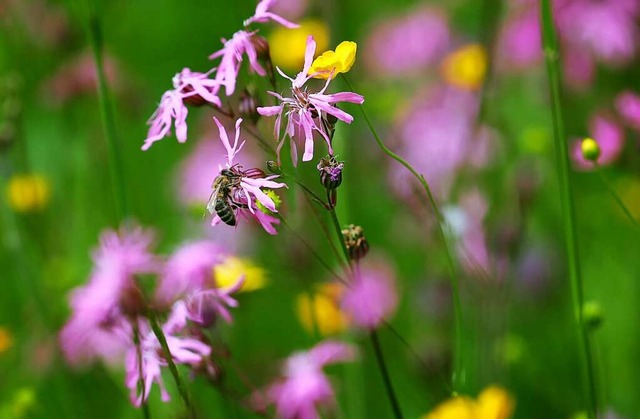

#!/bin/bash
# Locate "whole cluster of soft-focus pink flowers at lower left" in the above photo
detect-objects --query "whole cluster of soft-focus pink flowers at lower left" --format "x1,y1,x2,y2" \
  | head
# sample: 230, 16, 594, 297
60, 227, 244, 406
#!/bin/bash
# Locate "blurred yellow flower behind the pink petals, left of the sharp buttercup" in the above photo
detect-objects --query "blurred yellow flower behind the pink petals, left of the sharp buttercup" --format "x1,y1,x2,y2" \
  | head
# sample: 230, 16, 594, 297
268, 19, 329, 72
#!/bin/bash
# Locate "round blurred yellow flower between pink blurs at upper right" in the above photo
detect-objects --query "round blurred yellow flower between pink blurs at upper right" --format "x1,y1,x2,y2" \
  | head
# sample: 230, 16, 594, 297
441, 44, 487, 90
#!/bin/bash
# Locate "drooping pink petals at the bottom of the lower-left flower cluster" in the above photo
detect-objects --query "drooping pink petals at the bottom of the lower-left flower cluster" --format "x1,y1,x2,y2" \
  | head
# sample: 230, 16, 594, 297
125, 316, 211, 407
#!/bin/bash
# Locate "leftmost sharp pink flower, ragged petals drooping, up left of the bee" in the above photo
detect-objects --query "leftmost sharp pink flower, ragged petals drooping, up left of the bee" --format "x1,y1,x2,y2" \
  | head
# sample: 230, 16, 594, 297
142, 68, 221, 150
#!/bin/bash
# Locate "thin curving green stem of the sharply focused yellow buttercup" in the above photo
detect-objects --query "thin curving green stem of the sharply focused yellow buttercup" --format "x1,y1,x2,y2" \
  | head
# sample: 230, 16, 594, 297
343, 74, 465, 393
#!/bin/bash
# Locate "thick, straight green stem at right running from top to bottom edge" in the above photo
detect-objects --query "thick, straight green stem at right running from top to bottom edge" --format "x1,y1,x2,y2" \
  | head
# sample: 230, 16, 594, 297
540, 0, 598, 419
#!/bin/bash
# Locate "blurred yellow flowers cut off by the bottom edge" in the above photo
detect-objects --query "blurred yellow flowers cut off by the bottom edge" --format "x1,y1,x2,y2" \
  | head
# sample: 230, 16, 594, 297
422, 386, 515, 419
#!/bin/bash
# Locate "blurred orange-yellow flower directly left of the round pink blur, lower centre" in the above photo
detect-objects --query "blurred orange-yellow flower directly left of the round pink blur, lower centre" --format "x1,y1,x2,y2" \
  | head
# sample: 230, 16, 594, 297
296, 283, 348, 336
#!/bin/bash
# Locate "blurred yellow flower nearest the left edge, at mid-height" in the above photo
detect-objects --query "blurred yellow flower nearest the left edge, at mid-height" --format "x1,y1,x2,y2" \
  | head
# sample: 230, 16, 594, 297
7, 174, 51, 212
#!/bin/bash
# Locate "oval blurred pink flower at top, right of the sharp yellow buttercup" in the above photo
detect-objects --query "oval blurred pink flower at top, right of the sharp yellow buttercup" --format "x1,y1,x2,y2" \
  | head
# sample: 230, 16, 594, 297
363, 7, 451, 77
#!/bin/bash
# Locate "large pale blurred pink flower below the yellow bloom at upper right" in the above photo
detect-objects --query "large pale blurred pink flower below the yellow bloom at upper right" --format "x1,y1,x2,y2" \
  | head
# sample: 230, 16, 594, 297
390, 87, 484, 198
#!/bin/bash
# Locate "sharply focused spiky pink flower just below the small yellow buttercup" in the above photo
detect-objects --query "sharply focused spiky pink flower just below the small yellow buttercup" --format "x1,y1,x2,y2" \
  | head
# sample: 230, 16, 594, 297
258, 36, 364, 164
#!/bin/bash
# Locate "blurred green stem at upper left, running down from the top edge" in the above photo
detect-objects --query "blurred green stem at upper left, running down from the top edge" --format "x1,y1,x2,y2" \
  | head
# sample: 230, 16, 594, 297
87, 0, 129, 222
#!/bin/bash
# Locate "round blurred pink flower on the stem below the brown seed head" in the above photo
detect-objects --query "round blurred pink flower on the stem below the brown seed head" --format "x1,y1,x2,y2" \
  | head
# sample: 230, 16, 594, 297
341, 263, 398, 329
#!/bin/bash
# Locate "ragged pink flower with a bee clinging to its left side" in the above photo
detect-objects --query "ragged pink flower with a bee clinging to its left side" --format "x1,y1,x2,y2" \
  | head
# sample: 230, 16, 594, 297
207, 117, 286, 234
